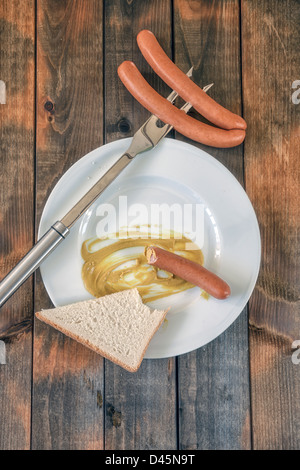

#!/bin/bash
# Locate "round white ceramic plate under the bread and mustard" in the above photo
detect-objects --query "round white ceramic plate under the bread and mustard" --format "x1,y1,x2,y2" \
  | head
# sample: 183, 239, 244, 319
39, 139, 261, 358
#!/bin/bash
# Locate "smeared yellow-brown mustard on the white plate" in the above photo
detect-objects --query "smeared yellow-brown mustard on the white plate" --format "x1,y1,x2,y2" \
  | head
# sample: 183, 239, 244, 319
81, 232, 203, 302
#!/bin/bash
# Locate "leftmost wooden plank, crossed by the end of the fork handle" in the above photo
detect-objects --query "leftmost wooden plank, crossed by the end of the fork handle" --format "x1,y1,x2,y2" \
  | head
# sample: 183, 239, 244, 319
0, 0, 35, 450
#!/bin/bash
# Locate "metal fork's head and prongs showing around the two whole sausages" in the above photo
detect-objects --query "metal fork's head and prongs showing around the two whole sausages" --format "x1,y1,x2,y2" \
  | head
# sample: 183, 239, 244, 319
126, 67, 213, 158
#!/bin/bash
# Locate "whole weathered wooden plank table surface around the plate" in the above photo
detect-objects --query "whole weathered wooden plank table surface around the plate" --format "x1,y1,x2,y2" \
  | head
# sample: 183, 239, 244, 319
0, 0, 300, 450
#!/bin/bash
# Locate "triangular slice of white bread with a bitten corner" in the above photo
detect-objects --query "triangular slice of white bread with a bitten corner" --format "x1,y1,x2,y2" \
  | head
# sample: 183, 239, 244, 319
36, 288, 167, 372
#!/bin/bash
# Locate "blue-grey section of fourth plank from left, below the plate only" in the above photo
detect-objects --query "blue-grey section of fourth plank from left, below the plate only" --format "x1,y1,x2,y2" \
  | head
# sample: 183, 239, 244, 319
178, 311, 251, 450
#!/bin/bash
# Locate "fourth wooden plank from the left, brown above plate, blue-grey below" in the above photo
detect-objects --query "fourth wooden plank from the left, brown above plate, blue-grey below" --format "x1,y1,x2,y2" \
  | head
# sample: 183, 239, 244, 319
174, 0, 251, 449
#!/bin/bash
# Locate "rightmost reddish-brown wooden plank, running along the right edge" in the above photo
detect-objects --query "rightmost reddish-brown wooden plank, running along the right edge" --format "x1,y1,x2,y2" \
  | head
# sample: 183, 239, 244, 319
242, 0, 300, 450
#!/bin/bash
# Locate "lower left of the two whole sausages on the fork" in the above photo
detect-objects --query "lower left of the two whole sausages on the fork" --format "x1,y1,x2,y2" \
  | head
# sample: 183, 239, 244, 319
118, 61, 245, 148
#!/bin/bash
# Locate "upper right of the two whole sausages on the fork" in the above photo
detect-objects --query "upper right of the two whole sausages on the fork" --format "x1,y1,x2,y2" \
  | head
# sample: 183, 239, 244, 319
137, 30, 247, 130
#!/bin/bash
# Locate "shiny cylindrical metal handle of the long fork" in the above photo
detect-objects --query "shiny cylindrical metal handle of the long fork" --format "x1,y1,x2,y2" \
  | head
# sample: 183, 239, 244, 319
0, 221, 69, 307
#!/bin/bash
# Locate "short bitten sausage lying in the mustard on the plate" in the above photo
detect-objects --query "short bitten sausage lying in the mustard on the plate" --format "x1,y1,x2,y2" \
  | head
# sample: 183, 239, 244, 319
145, 246, 230, 299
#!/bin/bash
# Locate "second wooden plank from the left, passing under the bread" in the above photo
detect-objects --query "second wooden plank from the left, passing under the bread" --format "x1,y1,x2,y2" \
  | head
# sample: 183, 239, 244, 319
32, 0, 103, 449
